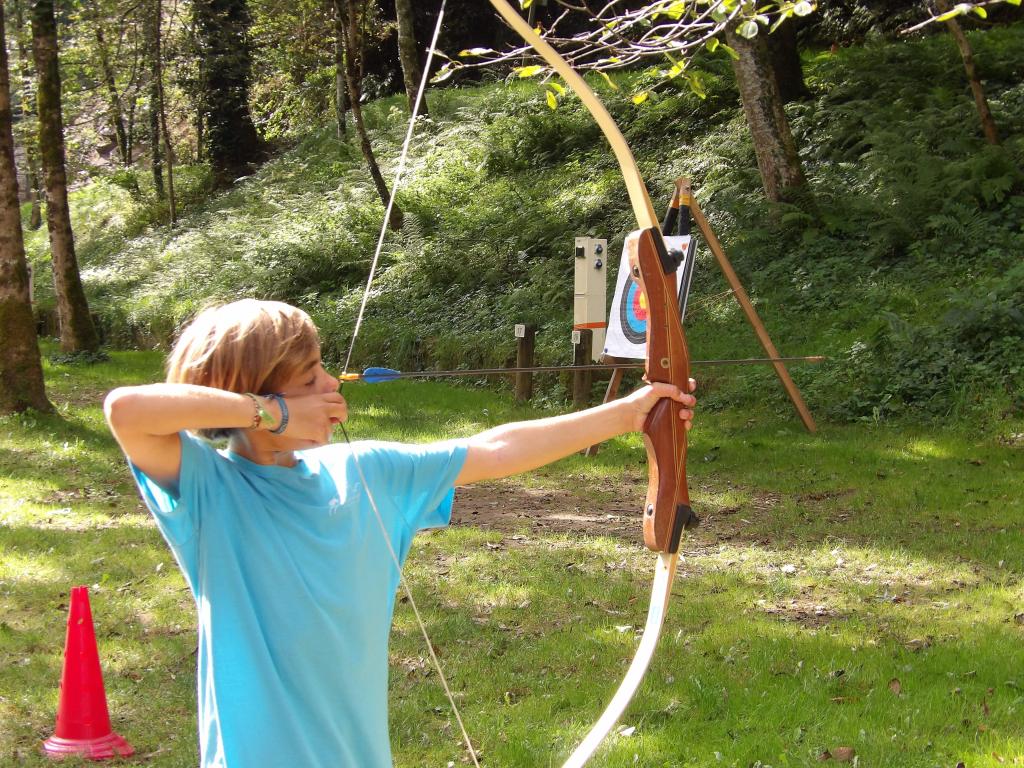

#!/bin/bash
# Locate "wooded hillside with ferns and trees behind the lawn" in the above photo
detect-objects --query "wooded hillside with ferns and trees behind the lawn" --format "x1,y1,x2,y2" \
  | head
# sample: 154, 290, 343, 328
5, 2, 1024, 428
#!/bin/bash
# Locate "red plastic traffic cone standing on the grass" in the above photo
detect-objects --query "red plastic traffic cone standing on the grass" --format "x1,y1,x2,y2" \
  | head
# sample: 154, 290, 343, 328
43, 587, 135, 760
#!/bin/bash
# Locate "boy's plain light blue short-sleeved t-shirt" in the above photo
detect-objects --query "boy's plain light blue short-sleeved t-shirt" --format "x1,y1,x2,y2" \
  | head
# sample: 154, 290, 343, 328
132, 433, 466, 768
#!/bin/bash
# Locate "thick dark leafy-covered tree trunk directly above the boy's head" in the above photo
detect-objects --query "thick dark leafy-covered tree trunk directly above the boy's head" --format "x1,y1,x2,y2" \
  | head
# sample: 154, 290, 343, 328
193, 0, 265, 186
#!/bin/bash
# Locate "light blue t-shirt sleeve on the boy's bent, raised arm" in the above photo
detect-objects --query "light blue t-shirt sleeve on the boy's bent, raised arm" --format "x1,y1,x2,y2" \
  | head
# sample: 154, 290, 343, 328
128, 432, 217, 552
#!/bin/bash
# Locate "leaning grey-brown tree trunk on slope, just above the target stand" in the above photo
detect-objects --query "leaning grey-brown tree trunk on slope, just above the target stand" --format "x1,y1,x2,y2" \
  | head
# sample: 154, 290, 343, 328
725, 26, 807, 203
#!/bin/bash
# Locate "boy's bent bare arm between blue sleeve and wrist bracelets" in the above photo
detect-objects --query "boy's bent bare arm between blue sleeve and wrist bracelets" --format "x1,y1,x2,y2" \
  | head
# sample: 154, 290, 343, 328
103, 384, 260, 487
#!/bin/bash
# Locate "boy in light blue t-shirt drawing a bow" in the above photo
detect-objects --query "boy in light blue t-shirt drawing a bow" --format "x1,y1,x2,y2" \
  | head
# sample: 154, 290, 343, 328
104, 299, 695, 768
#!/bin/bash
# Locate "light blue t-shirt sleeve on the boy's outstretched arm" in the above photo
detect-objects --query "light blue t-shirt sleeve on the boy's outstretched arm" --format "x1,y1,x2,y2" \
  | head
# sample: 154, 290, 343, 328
357, 440, 468, 531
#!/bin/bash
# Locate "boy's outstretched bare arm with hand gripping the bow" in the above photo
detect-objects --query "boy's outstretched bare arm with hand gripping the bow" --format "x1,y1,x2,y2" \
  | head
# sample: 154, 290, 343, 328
456, 380, 696, 485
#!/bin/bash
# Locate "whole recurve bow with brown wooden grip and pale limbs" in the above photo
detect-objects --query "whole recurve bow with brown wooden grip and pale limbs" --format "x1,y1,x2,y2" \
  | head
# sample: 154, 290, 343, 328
490, 0, 697, 768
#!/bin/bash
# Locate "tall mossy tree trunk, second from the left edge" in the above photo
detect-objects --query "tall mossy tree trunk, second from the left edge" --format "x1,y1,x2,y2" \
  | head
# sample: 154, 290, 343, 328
32, 0, 99, 352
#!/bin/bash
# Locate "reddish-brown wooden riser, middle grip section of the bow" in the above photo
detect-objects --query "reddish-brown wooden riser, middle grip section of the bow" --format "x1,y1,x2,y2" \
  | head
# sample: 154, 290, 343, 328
627, 227, 697, 553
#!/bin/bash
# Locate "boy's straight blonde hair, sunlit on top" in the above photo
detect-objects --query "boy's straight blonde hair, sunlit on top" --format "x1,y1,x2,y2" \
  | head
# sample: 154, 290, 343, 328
167, 299, 319, 438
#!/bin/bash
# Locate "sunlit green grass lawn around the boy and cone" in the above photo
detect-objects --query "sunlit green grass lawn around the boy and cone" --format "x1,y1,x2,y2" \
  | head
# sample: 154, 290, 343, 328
0, 352, 1024, 768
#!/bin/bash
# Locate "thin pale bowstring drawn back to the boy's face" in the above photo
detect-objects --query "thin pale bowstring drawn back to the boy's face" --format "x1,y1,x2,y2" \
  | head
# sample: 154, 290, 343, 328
338, 0, 480, 768
